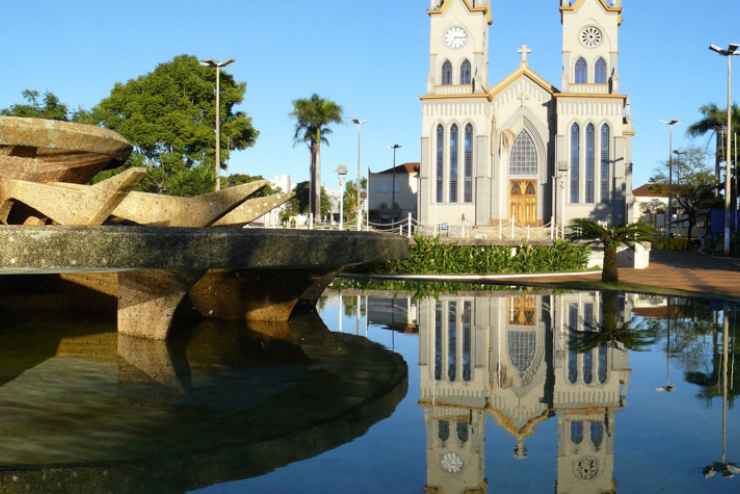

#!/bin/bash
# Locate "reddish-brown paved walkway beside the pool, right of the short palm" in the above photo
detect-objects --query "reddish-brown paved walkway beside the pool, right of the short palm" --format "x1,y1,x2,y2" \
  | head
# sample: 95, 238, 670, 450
516, 252, 740, 299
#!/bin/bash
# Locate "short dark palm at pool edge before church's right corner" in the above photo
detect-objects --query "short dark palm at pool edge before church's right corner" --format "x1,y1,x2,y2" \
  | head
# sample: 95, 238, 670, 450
568, 218, 655, 283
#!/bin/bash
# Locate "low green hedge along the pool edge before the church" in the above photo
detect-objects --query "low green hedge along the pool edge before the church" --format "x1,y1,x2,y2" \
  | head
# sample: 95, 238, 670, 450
377, 237, 589, 274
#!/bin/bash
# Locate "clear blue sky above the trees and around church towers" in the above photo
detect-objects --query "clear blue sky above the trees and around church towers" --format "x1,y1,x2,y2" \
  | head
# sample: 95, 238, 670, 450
0, 0, 740, 187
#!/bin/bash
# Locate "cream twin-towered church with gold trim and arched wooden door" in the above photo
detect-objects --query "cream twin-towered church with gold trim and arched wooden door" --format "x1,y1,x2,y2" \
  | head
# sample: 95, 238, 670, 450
418, 0, 634, 229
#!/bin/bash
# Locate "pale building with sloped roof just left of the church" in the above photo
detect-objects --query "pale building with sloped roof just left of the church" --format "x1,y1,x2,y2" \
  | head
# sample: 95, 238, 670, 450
368, 163, 419, 220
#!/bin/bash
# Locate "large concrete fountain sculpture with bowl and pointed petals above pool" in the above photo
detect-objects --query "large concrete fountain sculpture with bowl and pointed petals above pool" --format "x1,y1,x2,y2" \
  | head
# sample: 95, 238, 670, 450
0, 118, 407, 340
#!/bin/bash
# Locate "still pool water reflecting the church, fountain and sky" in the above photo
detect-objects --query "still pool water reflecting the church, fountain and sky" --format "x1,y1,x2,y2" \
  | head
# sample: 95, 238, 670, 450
0, 290, 740, 494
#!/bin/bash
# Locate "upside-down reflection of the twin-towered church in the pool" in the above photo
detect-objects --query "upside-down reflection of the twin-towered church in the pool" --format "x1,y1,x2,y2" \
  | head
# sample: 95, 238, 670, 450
419, 293, 630, 494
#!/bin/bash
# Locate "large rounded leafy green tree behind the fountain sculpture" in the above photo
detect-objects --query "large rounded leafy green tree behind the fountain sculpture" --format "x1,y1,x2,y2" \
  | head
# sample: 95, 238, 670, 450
88, 55, 259, 195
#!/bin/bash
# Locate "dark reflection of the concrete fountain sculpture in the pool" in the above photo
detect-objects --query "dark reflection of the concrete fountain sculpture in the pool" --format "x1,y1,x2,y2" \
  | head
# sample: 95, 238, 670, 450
0, 315, 407, 493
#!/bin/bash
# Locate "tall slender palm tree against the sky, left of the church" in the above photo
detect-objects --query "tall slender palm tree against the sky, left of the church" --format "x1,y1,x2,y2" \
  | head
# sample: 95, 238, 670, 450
290, 94, 342, 219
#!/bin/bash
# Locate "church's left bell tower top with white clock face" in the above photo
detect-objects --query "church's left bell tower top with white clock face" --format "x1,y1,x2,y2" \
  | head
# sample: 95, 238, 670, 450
427, 0, 492, 95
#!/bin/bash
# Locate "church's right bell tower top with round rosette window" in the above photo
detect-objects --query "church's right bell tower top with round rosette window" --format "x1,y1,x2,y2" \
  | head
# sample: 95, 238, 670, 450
560, 0, 622, 94
